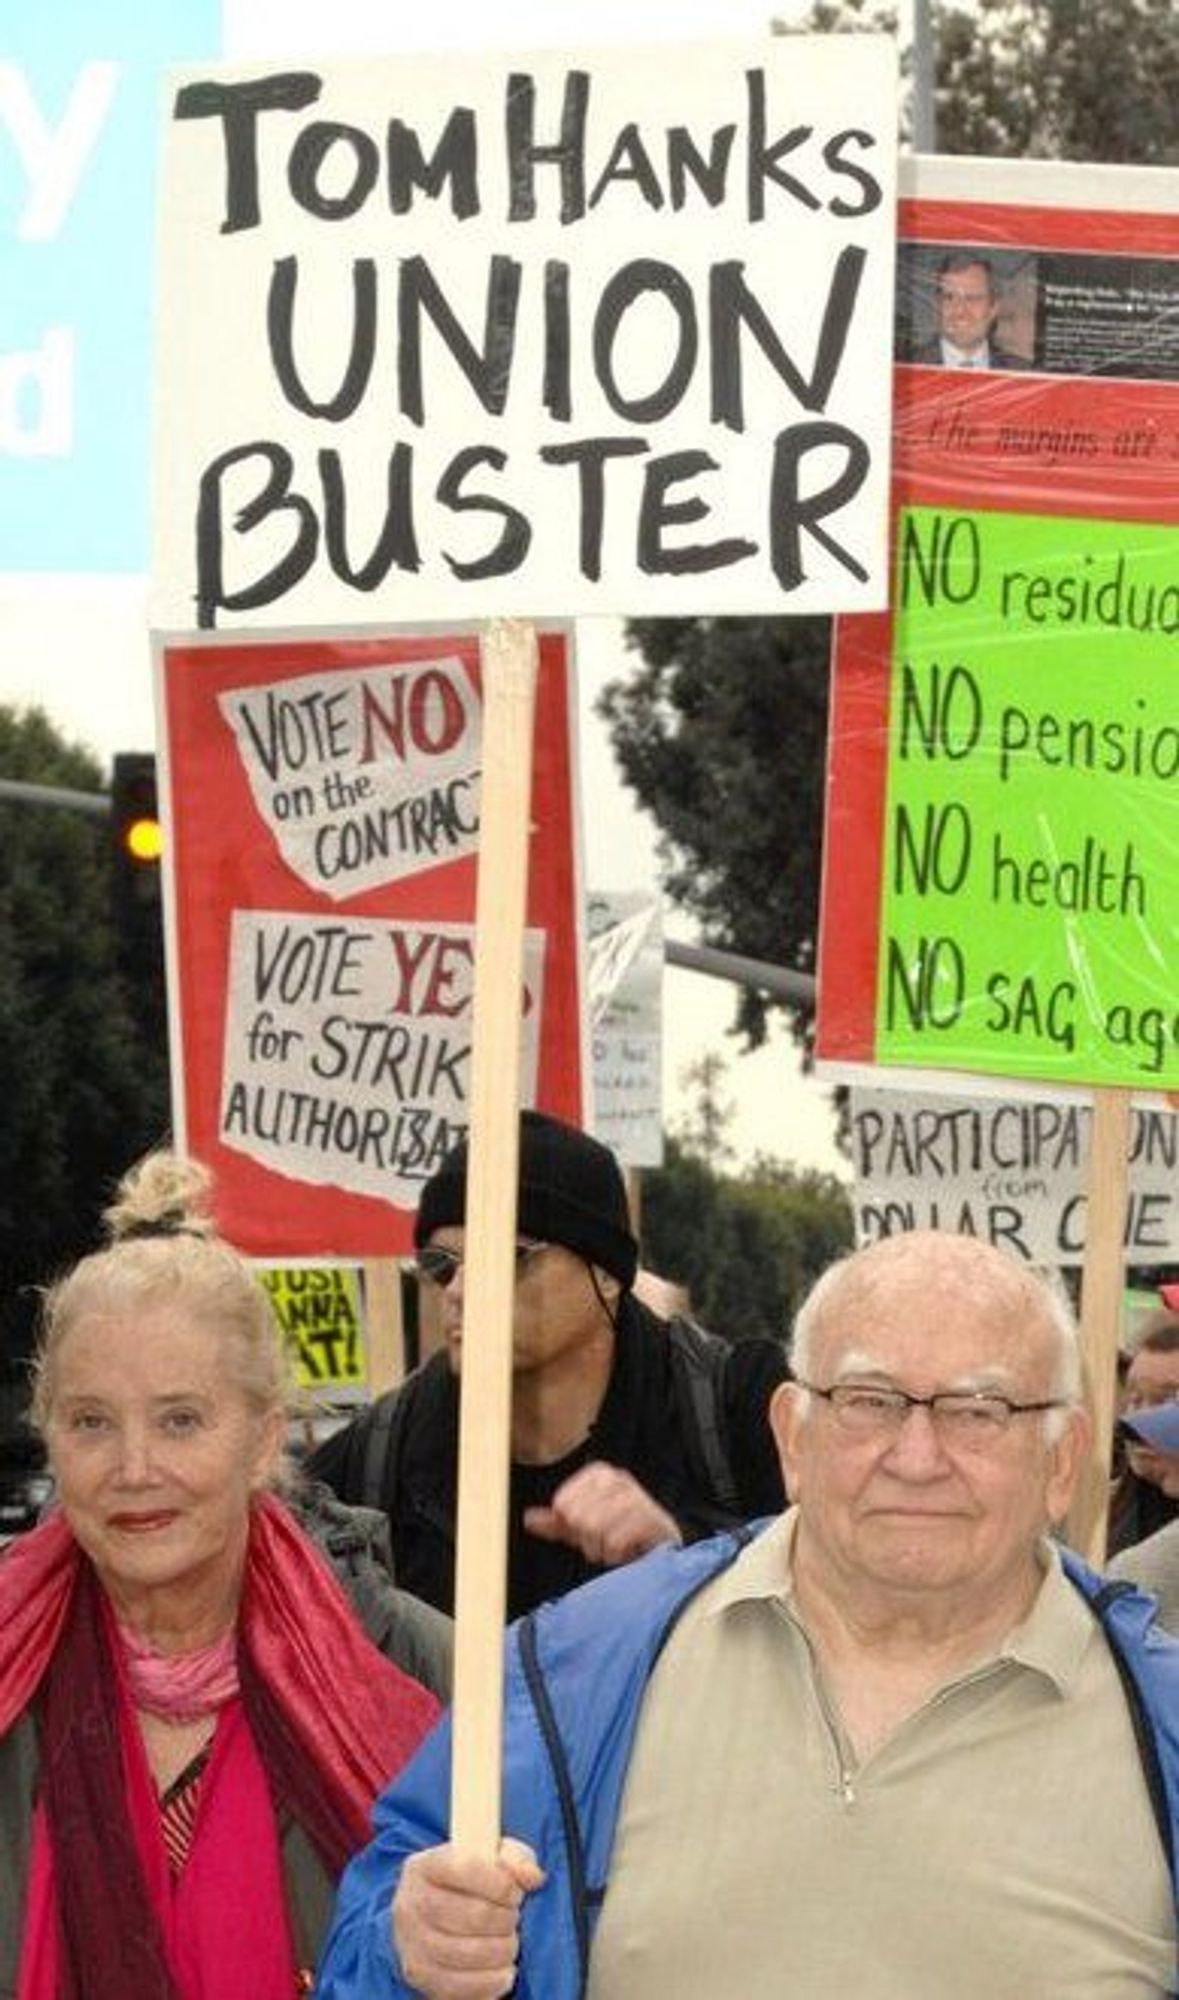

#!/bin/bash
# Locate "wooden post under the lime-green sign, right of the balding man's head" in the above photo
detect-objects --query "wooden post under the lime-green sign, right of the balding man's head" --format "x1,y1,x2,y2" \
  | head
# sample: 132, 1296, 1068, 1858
1067, 1088, 1131, 1566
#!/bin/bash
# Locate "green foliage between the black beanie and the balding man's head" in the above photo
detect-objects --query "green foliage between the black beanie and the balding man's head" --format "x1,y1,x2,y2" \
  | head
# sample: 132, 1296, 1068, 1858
641, 1140, 851, 1340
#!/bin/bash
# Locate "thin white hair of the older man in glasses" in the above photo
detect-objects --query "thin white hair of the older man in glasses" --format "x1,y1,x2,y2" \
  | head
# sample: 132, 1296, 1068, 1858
789, 1230, 1083, 1444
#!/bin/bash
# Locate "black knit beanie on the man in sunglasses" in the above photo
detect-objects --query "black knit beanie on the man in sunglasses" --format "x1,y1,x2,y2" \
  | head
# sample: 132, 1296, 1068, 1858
414, 1112, 639, 1290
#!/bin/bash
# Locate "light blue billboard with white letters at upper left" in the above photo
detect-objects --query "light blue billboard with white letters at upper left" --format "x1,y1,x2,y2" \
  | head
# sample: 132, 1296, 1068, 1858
0, 0, 222, 574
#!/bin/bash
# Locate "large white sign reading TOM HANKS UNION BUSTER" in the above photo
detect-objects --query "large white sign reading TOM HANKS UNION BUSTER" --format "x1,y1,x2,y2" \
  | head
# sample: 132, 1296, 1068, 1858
154, 36, 895, 628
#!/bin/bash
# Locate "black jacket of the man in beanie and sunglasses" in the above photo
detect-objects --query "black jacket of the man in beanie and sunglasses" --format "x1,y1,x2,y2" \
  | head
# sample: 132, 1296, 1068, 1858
308, 1294, 787, 1618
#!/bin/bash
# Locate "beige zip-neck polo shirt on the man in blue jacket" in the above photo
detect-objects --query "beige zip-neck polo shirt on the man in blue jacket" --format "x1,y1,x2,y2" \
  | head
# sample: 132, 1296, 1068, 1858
590, 1514, 1175, 2000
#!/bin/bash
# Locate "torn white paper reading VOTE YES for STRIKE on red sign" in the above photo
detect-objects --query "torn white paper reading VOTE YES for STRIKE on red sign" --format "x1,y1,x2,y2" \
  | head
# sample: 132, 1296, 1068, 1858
218, 910, 544, 1208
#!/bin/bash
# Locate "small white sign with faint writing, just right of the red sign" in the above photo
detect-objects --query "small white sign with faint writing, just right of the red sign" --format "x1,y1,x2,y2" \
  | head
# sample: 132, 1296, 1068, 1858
588, 892, 663, 1166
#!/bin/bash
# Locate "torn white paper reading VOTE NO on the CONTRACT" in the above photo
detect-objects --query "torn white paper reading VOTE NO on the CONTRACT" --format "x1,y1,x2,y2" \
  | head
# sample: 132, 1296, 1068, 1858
218, 660, 482, 902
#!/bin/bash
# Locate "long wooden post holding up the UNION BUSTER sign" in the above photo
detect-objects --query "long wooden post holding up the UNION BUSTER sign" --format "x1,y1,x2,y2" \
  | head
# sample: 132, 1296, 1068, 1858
450, 620, 538, 1858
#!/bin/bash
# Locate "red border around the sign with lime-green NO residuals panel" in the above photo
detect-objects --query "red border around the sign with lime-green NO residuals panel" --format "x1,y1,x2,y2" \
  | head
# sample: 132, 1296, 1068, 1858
815, 184, 1179, 1062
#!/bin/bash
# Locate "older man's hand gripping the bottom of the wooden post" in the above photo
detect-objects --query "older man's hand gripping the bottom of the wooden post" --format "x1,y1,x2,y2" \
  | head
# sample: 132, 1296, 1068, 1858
394, 1840, 544, 2000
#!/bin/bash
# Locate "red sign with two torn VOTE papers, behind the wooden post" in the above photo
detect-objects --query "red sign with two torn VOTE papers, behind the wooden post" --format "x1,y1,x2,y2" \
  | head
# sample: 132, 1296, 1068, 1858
158, 628, 584, 1260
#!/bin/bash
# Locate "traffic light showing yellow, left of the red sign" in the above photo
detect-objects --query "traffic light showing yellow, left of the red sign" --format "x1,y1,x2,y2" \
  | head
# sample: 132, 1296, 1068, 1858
110, 750, 164, 1030
